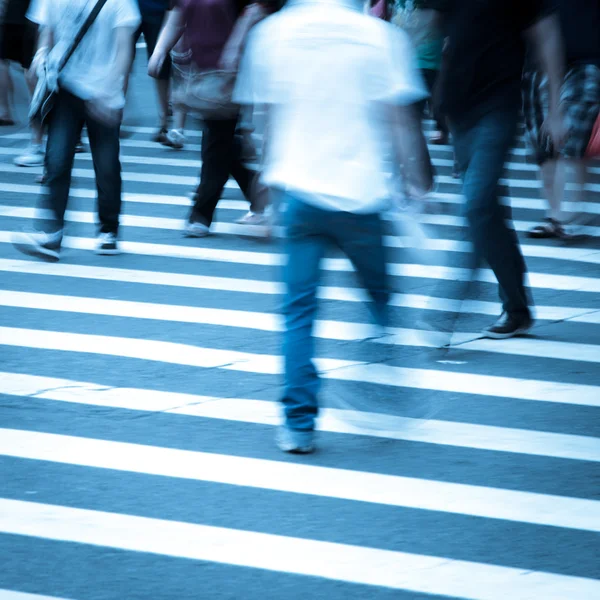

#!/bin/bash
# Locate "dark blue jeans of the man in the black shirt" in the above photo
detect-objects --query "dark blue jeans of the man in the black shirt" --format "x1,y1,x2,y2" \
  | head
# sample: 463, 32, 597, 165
450, 110, 529, 315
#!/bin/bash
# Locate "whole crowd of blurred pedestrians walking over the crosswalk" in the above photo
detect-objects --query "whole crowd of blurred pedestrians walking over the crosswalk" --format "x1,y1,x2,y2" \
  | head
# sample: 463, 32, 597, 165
0, 0, 600, 452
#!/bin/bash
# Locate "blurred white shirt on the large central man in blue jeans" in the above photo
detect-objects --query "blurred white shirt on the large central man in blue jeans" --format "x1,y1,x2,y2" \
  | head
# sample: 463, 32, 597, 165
235, 0, 427, 213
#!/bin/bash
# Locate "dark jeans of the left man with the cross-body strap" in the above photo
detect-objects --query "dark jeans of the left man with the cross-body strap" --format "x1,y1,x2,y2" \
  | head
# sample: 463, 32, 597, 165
44, 90, 121, 234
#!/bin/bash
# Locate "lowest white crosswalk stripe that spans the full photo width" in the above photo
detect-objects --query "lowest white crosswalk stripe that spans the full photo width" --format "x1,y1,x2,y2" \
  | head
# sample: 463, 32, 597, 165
0, 500, 600, 600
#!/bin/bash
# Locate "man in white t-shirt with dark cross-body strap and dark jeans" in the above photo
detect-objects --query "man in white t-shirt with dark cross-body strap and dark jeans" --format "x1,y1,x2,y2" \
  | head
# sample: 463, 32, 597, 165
14, 0, 140, 260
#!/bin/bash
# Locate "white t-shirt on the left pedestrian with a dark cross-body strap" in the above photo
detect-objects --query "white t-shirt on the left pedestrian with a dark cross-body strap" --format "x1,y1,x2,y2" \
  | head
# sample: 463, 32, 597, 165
27, 0, 141, 108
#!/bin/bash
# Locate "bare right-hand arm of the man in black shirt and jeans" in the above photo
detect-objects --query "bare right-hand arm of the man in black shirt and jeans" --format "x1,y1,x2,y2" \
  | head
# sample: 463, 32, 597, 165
526, 15, 565, 145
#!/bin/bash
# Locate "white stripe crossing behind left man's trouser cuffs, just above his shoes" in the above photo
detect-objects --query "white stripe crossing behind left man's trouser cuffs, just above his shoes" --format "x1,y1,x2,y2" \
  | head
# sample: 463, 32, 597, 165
0, 205, 600, 265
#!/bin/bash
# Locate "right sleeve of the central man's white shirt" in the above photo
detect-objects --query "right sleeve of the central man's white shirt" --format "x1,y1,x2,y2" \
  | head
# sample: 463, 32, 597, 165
368, 23, 429, 106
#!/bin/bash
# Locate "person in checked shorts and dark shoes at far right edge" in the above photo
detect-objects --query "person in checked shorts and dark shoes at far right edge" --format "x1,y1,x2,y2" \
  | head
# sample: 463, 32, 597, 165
523, 0, 600, 242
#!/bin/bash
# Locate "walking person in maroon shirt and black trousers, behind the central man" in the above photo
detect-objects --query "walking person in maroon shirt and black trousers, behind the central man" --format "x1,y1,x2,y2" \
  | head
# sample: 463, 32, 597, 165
148, 0, 276, 238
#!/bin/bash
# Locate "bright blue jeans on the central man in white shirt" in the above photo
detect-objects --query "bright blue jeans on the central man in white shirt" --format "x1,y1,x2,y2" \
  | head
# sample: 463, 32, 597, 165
278, 194, 390, 431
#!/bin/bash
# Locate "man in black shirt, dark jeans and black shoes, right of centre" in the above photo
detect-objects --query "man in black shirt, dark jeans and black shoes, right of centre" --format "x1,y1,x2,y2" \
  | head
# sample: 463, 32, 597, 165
440, 0, 564, 339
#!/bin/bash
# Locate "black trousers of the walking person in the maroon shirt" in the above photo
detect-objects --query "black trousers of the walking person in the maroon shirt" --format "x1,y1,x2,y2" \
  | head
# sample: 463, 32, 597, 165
190, 119, 256, 225
